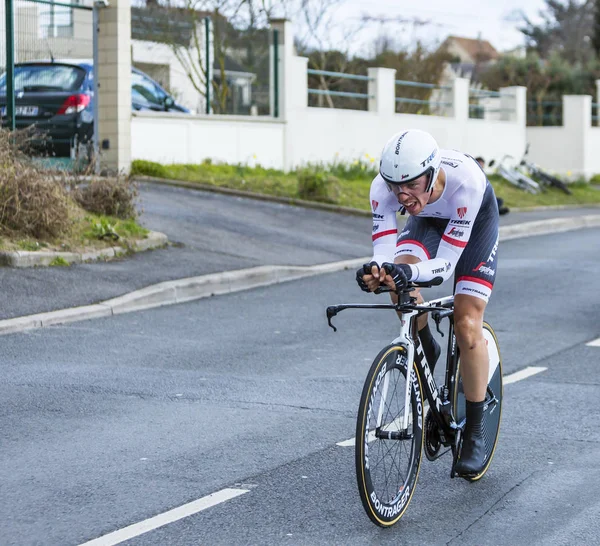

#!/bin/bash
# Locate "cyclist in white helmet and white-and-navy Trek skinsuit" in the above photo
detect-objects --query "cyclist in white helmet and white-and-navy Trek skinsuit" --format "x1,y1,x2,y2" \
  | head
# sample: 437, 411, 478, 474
356, 129, 498, 475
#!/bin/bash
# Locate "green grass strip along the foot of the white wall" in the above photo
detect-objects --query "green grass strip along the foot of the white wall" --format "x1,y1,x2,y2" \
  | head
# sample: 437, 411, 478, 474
132, 157, 600, 211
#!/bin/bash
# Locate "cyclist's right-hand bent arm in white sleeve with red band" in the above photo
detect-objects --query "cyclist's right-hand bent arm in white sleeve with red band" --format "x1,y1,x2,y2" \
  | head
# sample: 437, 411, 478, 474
410, 184, 486, 282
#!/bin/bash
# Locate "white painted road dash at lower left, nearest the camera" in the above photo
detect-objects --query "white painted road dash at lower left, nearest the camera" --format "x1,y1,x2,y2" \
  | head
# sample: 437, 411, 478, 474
80, 489, 250, 546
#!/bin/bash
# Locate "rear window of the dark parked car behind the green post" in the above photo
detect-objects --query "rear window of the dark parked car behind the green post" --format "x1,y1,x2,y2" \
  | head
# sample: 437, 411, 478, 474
0, 64, 85, 93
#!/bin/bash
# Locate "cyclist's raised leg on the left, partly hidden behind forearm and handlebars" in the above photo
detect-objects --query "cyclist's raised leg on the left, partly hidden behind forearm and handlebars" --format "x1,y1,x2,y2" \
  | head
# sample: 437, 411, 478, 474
392, 216, 447, 373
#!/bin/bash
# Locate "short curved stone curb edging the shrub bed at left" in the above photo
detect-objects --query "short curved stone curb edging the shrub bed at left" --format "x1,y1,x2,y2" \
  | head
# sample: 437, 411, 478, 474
0, 231, 169, 267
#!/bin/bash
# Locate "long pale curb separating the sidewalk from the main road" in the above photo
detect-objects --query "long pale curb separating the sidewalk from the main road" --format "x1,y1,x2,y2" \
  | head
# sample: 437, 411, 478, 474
0, 214, 600, 334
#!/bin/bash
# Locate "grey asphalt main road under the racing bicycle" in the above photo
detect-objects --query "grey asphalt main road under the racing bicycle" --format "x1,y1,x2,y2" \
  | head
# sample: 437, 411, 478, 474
0, 229, 600, 546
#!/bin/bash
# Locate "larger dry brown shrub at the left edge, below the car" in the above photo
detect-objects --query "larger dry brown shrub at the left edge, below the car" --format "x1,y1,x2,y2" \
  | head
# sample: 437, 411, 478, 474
0, 131, 70, 239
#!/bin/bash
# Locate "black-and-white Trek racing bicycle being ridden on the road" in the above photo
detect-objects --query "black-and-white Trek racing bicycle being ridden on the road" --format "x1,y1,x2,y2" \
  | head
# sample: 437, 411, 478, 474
327, 277, 502, 527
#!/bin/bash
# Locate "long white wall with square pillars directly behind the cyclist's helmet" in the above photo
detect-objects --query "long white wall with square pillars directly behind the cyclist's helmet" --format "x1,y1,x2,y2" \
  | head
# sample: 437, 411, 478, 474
132, 21, 526, 170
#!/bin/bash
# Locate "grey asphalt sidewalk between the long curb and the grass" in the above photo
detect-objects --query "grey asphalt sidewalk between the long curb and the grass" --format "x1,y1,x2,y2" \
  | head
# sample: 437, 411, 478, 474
0, 184, 600, 319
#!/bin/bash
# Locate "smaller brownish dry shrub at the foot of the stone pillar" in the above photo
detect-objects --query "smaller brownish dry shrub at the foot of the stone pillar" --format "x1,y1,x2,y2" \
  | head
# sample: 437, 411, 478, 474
72, 176, 138, 219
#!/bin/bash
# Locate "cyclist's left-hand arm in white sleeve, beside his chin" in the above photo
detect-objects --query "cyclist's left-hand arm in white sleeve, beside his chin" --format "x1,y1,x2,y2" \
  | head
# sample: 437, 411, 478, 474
370, 175, 400, 265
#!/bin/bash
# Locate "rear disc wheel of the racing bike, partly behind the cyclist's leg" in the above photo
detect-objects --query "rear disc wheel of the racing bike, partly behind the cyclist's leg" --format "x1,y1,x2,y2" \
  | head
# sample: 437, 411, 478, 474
452, 322, 504, 482
